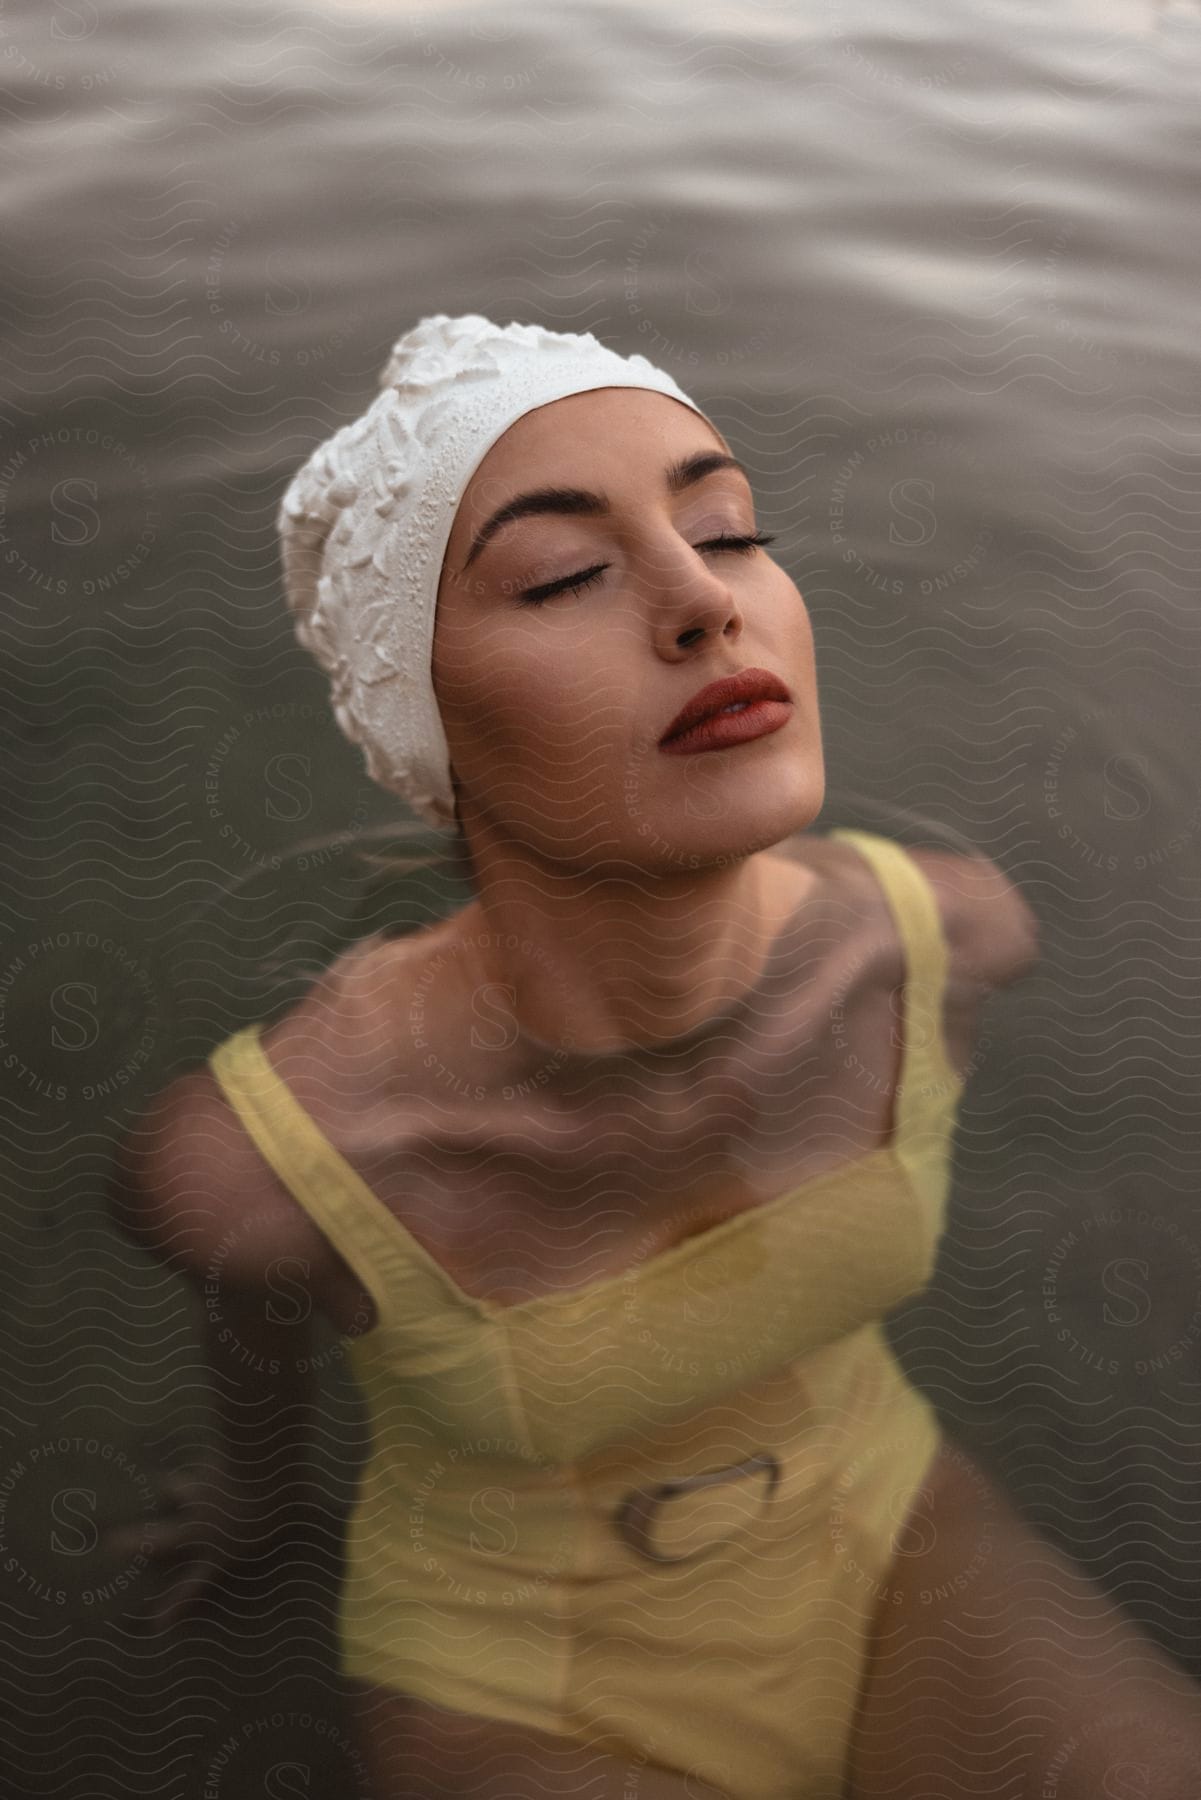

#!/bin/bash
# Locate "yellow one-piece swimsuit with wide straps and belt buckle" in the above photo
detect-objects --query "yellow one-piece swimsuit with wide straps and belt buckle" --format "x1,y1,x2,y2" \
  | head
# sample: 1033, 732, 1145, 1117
211, 830, 963, 1800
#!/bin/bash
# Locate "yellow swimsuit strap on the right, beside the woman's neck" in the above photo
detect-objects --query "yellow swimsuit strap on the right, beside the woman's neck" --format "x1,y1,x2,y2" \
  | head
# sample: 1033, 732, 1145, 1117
828, 828, 963, 1145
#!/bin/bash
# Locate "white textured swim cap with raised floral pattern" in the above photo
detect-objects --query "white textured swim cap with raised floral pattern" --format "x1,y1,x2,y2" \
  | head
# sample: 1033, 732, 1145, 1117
277, 313, 724, 826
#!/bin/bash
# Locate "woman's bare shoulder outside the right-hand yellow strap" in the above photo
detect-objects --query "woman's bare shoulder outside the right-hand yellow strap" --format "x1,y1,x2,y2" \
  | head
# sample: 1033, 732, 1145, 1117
909, 850, 1039, 988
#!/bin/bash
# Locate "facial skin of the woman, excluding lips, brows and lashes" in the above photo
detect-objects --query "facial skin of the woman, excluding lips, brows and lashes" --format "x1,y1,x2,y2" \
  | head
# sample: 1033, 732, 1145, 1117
432, 387, 825, 873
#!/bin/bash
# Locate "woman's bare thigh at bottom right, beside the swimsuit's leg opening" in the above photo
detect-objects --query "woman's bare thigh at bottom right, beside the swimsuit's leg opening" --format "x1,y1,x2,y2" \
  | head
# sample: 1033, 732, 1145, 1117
846, 1444, 1201, 1800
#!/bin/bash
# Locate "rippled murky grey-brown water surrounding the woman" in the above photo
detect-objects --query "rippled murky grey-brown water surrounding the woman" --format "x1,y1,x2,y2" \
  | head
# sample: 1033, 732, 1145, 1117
0, 0, 1201, 1800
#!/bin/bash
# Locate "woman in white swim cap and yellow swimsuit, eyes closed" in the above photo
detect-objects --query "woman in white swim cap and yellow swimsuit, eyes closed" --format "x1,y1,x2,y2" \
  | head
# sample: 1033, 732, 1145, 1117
108, 315, 1196, 1800
